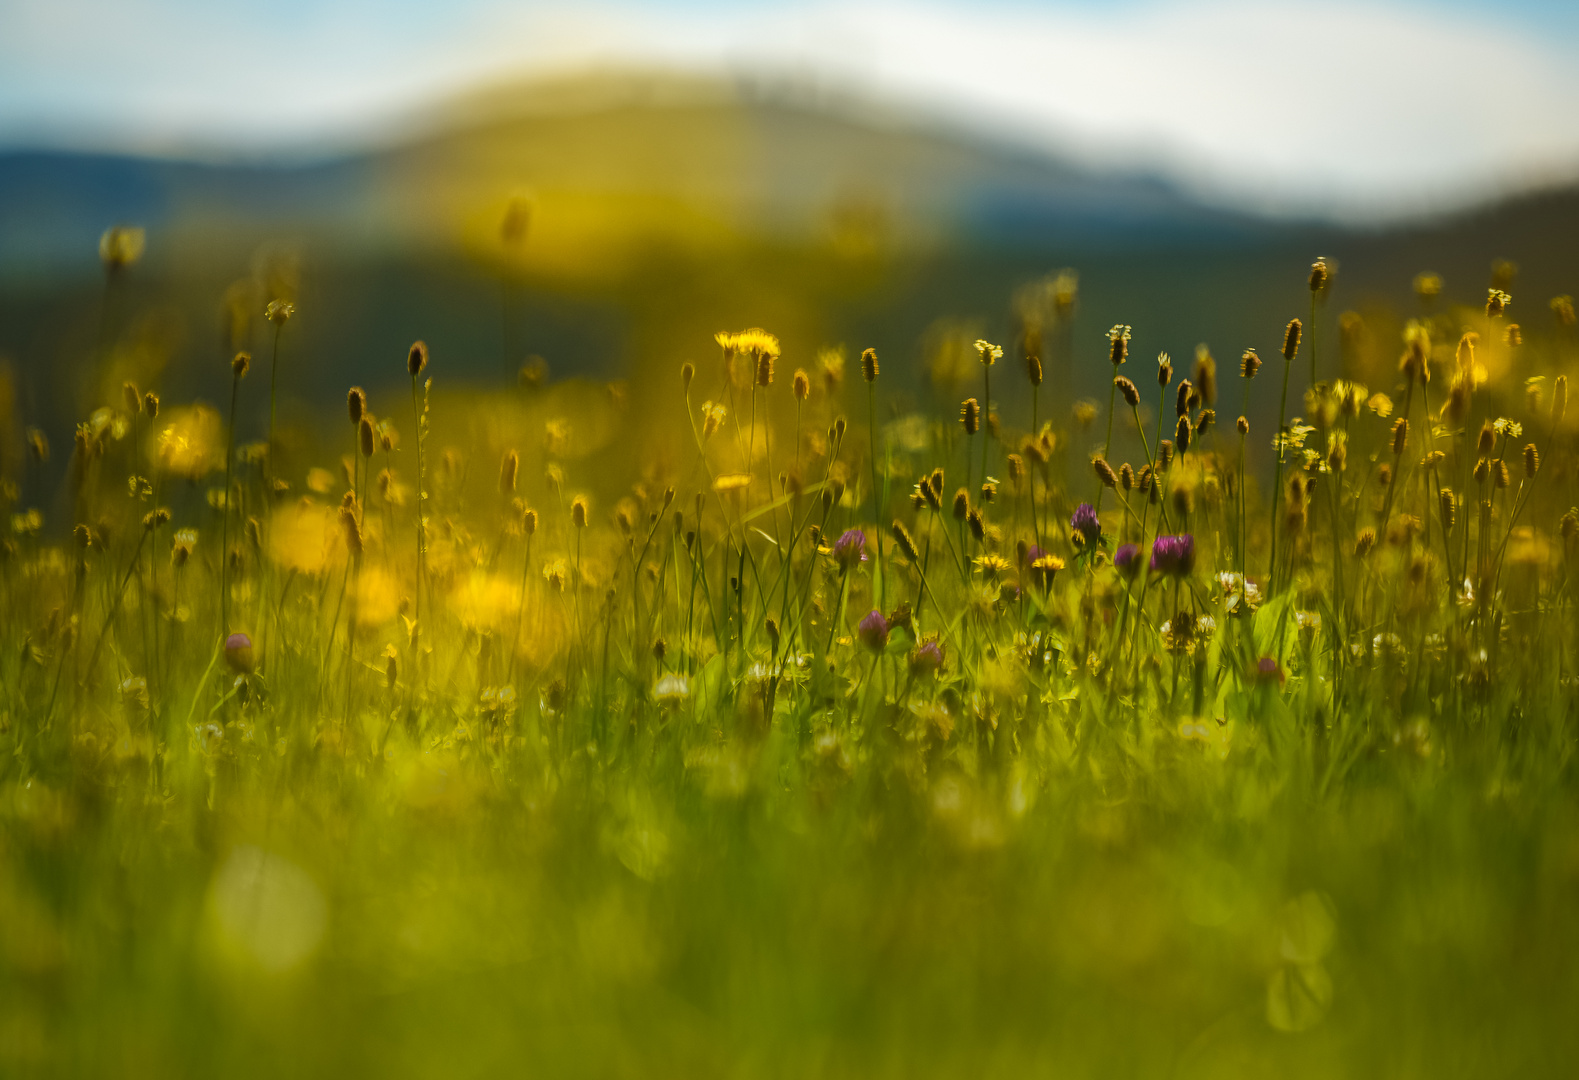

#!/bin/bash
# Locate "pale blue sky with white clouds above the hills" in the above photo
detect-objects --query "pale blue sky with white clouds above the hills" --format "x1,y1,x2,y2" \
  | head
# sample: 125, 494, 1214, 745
0, 0, 1579, 218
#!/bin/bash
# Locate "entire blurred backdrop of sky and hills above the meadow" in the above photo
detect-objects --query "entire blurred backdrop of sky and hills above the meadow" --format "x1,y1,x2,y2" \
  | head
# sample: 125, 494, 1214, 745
0, 0, 1579, 480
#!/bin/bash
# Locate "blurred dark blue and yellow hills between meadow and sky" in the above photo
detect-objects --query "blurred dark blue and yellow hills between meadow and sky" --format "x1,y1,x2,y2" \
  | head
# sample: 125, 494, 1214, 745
0, 74, 1579, 438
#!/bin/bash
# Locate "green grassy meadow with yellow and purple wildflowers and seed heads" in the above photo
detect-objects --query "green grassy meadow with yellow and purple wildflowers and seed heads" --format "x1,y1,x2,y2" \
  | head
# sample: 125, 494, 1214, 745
0, 217, 1579, 1077
